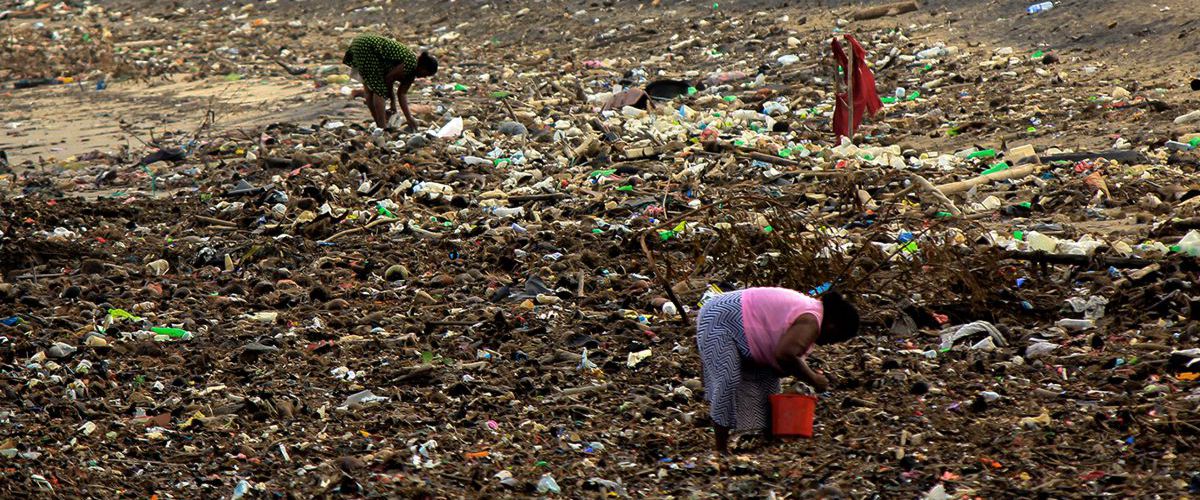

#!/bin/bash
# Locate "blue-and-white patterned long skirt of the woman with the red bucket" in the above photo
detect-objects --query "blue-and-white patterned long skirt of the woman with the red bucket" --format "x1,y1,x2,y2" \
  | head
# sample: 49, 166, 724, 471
696, 291, 780, 430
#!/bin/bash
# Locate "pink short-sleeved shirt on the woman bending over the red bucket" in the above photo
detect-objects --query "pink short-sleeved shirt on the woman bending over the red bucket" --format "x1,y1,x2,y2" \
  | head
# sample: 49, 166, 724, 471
742, 288, 824, 368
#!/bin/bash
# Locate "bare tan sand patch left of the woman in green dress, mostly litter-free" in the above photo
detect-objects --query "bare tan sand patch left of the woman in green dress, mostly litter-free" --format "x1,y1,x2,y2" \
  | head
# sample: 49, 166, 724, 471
0, 78, 348, 163
